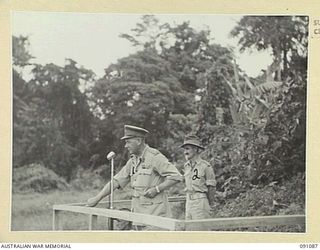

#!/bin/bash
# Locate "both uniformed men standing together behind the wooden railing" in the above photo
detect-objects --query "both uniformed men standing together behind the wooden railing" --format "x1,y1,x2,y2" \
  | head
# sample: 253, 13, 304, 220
87, 125, 215, 230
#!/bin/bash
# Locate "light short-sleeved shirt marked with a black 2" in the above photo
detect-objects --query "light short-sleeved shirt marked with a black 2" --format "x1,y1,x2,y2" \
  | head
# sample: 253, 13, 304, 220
184, 157, 216, 193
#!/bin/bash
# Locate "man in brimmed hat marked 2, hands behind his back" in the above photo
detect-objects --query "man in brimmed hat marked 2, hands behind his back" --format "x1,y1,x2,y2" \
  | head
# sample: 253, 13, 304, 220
181, 135, 216, 225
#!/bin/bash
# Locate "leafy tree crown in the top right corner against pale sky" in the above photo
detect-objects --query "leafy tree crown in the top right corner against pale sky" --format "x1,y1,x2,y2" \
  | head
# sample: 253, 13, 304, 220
231, 16, 309, 81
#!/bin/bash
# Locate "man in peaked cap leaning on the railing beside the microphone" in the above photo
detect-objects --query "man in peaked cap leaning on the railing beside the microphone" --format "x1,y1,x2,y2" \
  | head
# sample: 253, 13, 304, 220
87, 125, 183, 230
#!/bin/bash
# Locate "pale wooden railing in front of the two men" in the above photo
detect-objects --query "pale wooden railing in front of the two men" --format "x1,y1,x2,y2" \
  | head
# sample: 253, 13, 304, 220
53, 197, 305, 231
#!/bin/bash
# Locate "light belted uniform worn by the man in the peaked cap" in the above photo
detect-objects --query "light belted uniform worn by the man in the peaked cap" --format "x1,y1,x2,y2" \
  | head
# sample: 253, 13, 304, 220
114, 145, 182, 217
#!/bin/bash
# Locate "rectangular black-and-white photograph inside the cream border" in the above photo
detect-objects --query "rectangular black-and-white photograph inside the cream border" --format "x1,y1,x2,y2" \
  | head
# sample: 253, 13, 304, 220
10, 11, 310, 233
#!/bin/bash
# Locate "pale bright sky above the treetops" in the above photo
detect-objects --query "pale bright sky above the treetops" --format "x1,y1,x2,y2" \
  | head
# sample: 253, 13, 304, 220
12, 12, 271, 77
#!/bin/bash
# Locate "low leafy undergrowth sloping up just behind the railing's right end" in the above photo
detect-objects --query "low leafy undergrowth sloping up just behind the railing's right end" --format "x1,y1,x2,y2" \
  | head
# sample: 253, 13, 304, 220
215, 174, 305, 217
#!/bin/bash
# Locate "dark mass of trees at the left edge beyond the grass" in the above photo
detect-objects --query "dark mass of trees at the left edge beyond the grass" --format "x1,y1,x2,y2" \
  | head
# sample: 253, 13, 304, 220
12, 37, 94, 180
